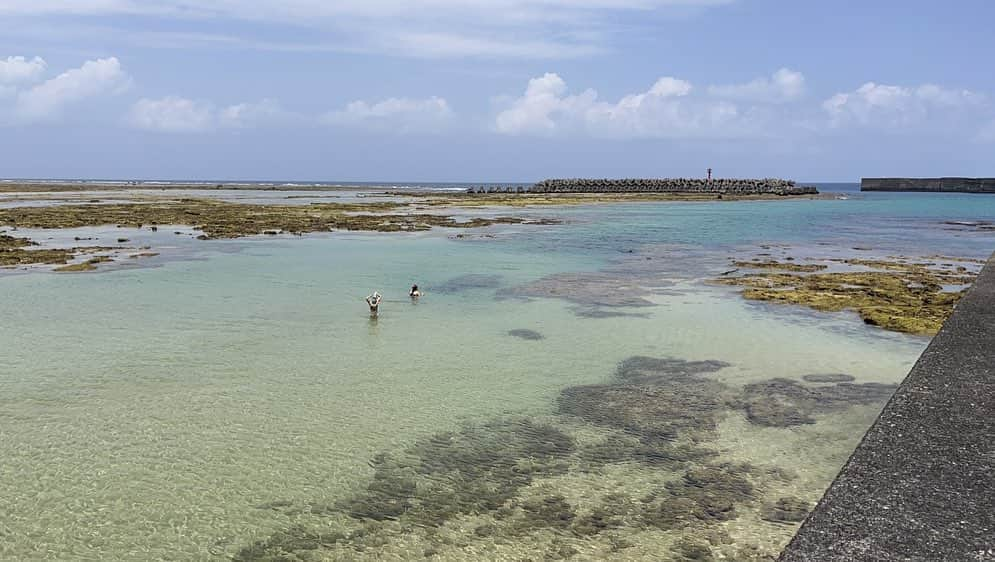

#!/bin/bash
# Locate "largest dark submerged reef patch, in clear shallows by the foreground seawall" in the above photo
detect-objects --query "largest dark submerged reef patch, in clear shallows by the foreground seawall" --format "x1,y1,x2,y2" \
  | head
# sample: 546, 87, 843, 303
235, 356, 880, 561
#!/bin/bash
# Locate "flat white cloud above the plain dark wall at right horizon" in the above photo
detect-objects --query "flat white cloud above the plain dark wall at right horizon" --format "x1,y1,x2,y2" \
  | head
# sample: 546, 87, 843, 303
822, 82, 986, 127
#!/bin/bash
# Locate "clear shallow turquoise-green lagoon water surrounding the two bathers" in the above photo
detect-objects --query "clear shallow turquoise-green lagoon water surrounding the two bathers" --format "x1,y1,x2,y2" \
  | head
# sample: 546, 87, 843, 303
0, 190, 995, 560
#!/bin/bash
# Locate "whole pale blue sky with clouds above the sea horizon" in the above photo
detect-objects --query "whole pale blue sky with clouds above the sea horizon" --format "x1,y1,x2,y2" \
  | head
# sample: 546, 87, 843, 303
0, 0, 995, 181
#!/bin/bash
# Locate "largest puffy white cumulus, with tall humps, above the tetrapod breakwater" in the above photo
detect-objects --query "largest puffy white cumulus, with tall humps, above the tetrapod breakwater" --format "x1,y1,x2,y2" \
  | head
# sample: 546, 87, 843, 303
494, 73, 765, 138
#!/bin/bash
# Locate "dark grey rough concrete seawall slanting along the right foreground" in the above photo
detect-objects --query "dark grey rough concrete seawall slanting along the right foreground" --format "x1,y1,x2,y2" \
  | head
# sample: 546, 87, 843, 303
780, 252, 995, 562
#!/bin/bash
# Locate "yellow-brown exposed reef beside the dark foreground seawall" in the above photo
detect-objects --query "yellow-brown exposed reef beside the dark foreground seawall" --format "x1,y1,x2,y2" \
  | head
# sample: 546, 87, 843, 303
716, 259, 976, 335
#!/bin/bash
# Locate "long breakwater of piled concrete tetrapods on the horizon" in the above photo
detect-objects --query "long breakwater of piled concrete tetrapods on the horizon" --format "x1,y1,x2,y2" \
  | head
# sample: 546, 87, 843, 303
468, 178, 818, 195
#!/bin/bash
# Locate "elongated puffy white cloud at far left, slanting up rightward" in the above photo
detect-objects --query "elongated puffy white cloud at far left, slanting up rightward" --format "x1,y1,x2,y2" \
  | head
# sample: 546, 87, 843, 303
13, 57, 131, 121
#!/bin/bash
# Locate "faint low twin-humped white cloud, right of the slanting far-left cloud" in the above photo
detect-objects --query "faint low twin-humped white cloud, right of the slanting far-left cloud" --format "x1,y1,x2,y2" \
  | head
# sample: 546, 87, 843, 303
127, 96, 291, 133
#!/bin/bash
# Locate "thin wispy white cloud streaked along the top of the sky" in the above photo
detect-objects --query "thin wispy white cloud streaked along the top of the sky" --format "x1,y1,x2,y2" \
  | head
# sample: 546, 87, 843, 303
0, 0, 735, 58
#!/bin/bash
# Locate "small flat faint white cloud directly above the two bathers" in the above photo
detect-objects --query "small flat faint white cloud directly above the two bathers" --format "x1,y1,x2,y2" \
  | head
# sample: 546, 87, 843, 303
322, 96, 454, 133
